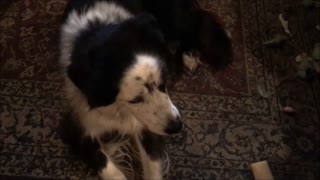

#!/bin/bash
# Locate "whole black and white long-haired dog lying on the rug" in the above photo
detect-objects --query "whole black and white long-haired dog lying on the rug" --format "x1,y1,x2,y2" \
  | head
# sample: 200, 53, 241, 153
60, 0, 231, 179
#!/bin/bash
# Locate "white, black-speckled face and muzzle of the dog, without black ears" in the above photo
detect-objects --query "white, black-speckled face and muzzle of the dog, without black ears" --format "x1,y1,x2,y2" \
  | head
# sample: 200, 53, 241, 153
116, 54, 182, 134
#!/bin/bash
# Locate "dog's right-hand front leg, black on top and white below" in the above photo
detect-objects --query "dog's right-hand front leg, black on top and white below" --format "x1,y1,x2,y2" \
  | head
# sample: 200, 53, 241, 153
137, 131, 164, 180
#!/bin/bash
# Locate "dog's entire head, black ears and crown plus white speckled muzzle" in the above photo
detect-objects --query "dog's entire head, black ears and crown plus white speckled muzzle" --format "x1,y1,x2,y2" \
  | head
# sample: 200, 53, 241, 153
67, 14, 182, 135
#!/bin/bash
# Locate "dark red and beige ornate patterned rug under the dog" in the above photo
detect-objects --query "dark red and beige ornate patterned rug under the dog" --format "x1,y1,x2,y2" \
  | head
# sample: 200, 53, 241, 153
0, 0, 320, 180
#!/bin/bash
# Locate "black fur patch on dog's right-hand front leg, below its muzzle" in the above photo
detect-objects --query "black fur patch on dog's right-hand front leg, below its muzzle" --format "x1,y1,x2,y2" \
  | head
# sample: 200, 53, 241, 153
141, 130, 165, 160
